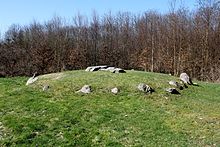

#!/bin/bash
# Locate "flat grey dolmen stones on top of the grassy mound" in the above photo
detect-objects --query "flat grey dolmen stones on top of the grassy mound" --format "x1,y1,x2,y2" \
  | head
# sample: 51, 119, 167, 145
85, 65, 126, 73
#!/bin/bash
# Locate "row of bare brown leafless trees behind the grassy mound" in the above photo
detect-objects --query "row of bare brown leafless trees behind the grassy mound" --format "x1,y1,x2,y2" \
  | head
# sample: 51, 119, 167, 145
0, 0, 220, 81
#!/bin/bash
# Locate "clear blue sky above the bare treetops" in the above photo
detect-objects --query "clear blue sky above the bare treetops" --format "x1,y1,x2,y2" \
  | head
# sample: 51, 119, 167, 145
0, 0, 196, 34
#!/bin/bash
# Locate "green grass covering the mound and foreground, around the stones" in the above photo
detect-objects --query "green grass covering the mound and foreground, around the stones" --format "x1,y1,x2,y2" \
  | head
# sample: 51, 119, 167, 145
0, 71, 220, 147
